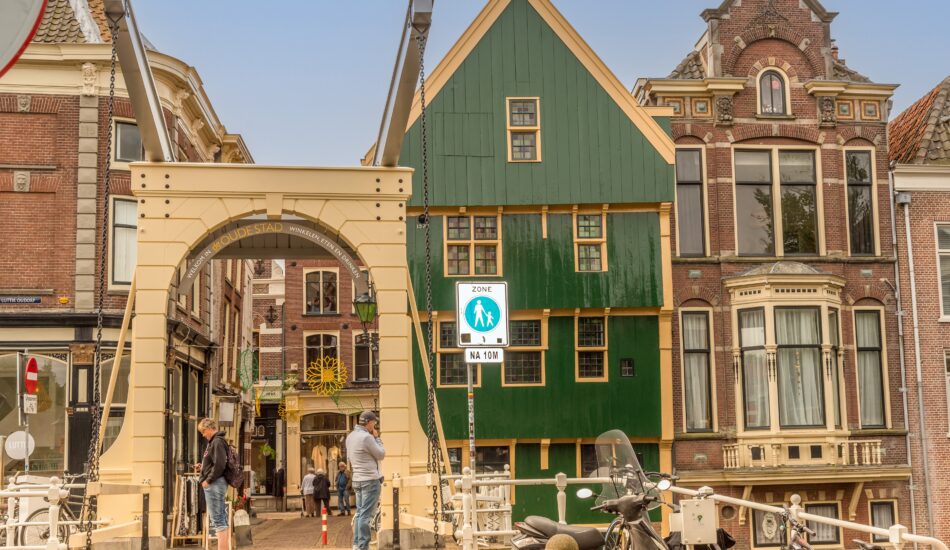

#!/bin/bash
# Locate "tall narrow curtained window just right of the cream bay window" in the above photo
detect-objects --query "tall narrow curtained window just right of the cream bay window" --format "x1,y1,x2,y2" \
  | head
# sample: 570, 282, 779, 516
854, 311, 884, 426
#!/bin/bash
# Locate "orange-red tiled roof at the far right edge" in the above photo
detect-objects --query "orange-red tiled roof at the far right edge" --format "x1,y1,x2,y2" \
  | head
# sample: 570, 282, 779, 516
888, 76, 950, 164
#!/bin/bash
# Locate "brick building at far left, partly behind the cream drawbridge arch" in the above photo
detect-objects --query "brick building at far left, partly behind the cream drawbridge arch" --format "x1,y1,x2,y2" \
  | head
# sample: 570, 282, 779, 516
0, 0, 252, 536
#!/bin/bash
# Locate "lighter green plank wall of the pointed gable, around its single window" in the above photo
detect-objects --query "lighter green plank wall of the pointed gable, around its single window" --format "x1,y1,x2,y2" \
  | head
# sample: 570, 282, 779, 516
400, 0, 673, 206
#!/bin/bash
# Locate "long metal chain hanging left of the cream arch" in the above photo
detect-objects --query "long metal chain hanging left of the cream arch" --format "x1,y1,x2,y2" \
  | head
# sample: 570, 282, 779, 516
83, 16, 121, 550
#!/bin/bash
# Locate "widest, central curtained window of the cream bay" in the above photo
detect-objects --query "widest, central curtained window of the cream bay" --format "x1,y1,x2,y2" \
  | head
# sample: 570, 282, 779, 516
775, 308, 825, 426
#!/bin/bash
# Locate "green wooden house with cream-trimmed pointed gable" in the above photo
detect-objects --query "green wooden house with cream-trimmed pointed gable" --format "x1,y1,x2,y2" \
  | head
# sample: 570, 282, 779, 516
401, 0, 674, 522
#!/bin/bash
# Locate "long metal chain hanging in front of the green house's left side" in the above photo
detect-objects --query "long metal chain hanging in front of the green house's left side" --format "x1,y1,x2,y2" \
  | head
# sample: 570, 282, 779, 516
416, 31, 445, 547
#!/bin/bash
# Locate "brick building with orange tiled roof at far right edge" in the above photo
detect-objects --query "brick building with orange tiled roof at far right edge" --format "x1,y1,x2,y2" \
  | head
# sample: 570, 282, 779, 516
889, 78, 950, 540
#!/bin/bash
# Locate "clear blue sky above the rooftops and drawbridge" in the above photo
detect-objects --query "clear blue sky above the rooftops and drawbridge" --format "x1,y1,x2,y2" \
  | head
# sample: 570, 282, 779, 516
134, 0, 950, 166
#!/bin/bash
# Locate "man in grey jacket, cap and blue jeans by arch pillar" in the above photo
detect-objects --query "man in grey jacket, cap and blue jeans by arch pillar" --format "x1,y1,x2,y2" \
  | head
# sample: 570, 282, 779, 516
346, 411, 386, 550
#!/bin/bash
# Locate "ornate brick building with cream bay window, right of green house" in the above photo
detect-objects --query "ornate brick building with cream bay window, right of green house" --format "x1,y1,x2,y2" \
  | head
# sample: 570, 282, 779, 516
634, 0, 912, 548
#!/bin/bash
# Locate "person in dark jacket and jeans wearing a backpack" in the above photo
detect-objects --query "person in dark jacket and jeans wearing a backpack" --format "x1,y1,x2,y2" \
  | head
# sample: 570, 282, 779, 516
198, 418, 231, 550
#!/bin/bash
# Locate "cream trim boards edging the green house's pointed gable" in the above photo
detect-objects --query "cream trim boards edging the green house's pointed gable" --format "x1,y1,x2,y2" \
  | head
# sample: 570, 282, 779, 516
406, 0, 675, 164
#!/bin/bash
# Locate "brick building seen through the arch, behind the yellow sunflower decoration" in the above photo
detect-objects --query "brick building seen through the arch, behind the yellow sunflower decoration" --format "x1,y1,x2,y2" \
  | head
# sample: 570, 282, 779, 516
252, 254, 379, 506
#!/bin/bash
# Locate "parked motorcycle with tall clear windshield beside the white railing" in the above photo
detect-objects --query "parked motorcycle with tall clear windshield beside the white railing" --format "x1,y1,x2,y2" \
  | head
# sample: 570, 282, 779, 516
511, 430, 671, 550
